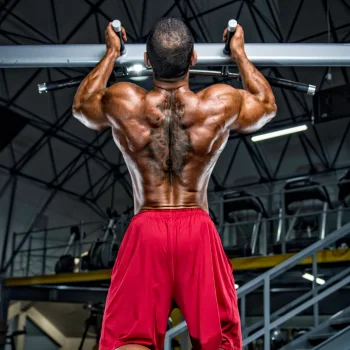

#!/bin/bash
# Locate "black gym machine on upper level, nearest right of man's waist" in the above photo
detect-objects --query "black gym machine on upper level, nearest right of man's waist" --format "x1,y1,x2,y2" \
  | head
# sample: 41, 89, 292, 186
223, 191, 268, 258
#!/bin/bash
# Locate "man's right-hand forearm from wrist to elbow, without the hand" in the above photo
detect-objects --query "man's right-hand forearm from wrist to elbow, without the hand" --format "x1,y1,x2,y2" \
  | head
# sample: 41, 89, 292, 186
232, 51, 275, 108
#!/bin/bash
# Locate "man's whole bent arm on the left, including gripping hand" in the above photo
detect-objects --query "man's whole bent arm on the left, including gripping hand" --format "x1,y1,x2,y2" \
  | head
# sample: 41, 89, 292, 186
72, 23, 127, 130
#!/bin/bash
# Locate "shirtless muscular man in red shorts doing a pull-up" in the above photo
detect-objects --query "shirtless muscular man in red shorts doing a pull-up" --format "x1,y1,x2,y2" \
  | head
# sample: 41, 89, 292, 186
73, 18, 276, 350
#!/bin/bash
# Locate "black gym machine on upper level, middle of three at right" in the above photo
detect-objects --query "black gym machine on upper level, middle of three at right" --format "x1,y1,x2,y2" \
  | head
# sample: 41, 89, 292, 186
273, 177, 333, 254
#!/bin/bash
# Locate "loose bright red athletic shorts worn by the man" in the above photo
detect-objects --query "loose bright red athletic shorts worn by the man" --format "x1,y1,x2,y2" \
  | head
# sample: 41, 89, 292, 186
99, 209, 242, 350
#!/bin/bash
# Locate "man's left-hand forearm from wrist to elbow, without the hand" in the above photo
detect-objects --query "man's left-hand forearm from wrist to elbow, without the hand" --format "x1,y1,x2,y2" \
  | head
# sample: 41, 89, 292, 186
74, 50, 120, 107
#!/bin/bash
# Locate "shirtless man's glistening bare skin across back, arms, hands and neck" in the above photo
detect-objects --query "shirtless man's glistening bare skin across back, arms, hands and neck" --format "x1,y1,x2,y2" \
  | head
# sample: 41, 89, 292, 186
73, 25, 276, 213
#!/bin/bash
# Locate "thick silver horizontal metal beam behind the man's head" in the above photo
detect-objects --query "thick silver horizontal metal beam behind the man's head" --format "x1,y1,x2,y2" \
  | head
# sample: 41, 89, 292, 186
0, 43, 350, 68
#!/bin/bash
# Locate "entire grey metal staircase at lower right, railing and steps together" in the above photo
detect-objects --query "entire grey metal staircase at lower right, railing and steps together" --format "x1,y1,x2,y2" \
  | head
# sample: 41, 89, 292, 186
164, 223, 350, 350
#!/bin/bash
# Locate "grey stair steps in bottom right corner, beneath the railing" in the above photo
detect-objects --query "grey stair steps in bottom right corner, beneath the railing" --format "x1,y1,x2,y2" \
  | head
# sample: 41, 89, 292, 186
280, 300, 350, 350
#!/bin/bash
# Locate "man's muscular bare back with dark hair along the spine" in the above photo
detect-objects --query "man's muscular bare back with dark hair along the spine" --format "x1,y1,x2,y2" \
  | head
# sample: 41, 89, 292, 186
104, 84, 229, 212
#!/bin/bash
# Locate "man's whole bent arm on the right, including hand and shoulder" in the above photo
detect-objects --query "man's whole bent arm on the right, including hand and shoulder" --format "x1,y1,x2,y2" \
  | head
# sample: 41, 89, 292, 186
217, 26, 277, 133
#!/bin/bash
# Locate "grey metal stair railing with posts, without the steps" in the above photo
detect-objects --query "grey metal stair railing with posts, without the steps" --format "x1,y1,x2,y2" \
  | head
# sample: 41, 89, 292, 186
164, 223, 350, 350
